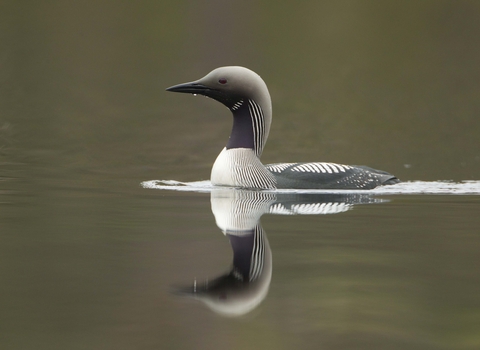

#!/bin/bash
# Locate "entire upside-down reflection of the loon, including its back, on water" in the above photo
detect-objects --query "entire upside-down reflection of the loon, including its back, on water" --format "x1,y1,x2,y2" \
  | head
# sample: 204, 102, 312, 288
176, 188, 385, 316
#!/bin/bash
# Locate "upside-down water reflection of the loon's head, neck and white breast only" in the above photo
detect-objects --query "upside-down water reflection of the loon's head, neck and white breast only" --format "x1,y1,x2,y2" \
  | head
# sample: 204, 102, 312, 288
175, 189, 275, 316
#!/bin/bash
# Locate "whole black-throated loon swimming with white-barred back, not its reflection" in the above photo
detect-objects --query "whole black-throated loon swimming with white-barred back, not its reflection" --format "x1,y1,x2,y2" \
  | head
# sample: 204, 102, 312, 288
166, 66, 400, 190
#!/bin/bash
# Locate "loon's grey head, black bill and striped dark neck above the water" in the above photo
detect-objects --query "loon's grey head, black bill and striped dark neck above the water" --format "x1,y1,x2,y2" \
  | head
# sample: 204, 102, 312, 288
167, 66, 272, 157
